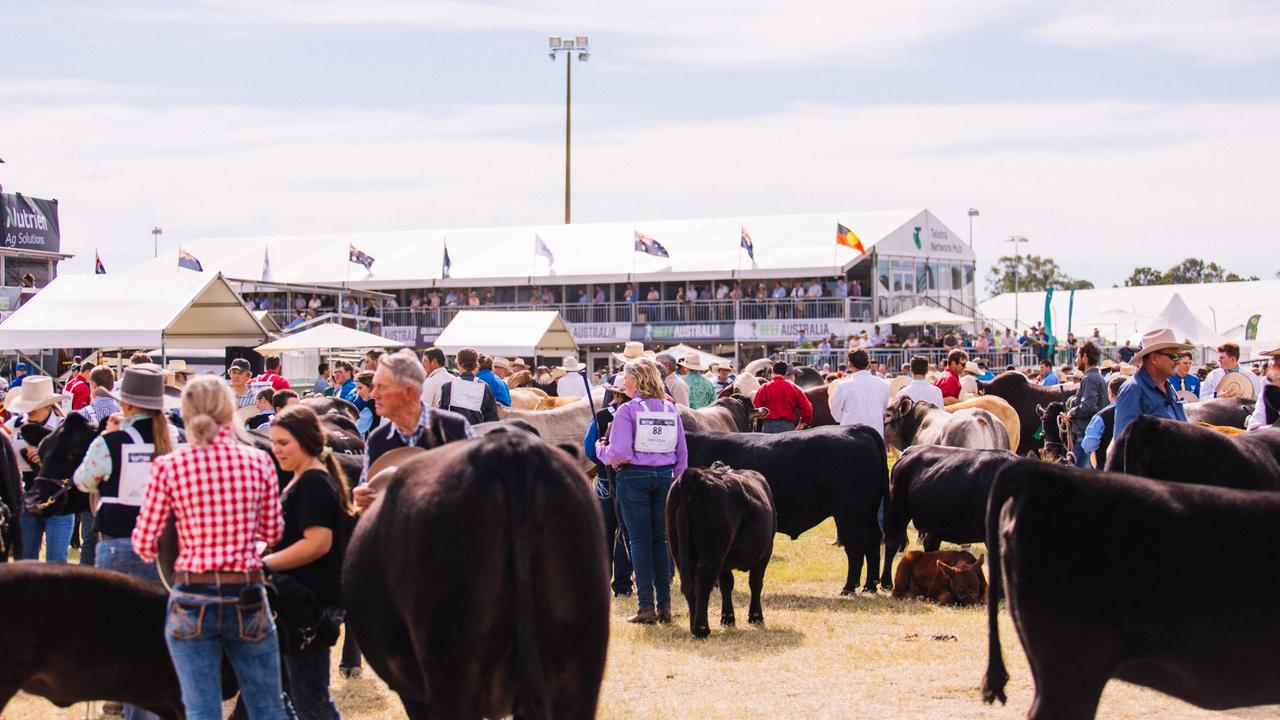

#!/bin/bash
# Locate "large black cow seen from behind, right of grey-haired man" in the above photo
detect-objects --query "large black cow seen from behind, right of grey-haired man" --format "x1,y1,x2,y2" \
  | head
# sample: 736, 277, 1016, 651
343, 432, 609, 720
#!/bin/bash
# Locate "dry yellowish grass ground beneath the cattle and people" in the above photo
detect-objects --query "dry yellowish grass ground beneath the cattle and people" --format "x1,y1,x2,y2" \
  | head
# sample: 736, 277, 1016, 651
4, 521, 1280, 720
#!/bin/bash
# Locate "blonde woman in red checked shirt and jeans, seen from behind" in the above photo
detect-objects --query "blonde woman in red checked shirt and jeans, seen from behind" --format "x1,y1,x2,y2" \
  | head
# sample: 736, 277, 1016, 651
133, 375, 285, 720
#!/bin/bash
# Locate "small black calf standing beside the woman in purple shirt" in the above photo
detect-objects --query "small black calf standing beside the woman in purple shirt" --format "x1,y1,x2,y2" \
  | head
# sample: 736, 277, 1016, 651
667, 462, 777, 638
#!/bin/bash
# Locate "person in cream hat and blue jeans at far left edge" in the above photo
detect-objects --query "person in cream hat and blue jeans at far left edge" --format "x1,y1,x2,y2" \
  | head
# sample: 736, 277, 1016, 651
5, 375, 76, 562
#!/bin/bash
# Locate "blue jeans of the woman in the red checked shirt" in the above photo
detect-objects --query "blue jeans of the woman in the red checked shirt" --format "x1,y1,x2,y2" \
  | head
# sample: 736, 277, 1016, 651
165, 583, 288, 720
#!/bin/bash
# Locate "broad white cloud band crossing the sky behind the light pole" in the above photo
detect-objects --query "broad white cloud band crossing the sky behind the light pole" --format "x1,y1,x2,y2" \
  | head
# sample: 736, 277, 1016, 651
4, 94, 1280, 284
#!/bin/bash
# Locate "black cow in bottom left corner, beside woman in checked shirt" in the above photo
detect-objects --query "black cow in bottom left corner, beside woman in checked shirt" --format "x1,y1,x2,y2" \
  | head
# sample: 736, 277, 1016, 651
0, 562, 236, 717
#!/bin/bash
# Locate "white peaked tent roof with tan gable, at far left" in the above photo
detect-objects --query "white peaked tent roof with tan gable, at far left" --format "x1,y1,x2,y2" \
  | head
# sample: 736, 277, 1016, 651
0, 270, 269, 348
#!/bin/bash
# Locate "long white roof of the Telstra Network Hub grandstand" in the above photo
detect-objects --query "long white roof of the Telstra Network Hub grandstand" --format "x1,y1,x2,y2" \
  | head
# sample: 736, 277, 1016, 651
127, 209, 974, 290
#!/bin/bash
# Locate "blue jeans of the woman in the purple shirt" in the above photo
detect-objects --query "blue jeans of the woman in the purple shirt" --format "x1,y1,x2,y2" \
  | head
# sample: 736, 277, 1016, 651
616, 465, 675, 609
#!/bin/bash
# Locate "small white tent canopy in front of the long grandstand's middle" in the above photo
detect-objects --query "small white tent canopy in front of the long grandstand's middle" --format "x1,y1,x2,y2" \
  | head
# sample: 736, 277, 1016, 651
435, 310, 577, 357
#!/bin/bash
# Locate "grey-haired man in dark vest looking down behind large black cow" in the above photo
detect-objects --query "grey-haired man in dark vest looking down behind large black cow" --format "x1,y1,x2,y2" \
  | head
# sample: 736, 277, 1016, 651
353, 350, 475, 509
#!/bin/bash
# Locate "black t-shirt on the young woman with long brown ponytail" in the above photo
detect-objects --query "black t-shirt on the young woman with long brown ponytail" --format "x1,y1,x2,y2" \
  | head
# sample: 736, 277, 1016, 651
273, 470, 342, 607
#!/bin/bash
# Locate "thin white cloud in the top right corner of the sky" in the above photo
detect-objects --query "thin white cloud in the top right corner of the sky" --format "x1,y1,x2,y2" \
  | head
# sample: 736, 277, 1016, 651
1036, 0, 1280, 64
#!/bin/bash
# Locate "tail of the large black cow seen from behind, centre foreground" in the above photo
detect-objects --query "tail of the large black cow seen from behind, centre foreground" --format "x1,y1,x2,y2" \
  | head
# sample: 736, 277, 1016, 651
495, 443, 550, 720
